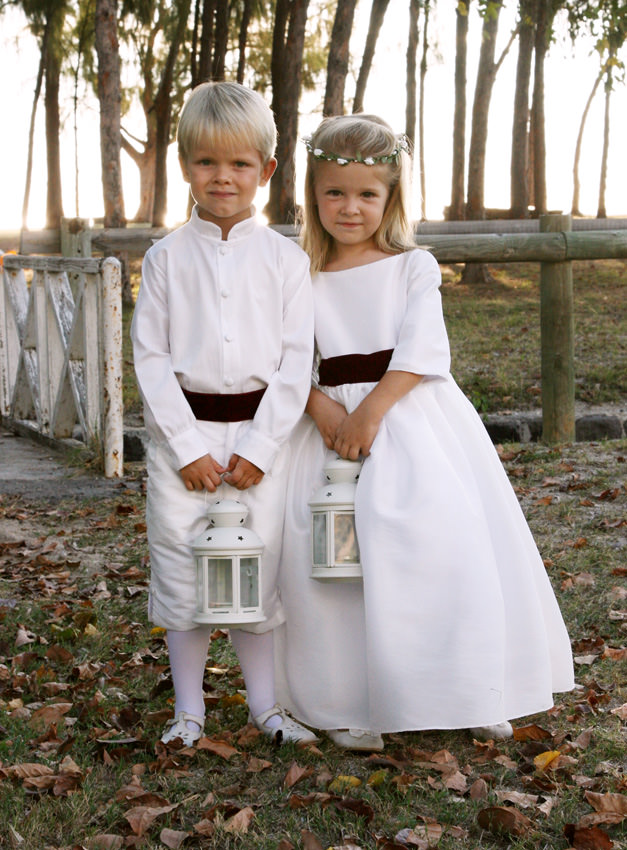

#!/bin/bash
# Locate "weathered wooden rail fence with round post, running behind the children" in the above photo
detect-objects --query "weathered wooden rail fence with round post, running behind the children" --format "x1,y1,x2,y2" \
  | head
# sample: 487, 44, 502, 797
0, 219, 627, 458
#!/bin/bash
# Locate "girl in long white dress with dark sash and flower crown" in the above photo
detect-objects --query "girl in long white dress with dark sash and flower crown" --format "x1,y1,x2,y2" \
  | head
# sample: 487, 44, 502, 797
277, 115, 573, 750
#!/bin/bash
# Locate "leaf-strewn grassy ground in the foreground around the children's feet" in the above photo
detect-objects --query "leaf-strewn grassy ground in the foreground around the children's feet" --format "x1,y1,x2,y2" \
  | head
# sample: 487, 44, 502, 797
0, 441, 627, 850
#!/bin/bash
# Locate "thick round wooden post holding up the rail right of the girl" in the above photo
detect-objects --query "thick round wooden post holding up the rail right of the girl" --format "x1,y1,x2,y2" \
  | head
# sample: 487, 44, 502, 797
540, 215, 575, 443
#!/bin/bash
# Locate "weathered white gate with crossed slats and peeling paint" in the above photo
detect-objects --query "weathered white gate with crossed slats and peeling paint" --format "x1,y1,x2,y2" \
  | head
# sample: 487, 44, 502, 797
0, 254, 124, 478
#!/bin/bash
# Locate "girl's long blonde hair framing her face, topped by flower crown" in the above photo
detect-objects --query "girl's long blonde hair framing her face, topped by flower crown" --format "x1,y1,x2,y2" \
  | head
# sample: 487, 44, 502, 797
302, 114, 416, 272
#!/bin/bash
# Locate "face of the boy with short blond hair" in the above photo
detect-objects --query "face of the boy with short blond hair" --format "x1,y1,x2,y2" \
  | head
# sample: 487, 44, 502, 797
179, 143, 276, 239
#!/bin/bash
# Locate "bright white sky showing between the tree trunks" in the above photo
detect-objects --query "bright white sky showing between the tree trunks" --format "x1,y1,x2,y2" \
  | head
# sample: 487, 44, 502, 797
0, 0, 627, 230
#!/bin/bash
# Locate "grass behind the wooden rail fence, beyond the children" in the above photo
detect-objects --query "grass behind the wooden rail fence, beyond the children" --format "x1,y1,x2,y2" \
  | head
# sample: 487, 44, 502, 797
123, 260, 627, 416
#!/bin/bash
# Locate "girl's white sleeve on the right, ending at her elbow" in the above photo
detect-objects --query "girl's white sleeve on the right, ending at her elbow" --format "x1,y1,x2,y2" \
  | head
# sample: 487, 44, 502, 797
388, 250, 451, 376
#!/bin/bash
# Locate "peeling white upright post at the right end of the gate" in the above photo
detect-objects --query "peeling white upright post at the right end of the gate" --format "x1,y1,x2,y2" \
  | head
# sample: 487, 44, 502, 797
102, 257, 124, 478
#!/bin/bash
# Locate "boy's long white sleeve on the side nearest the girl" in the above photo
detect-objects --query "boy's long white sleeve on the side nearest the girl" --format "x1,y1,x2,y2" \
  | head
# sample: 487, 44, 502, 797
235, 250, 314, 472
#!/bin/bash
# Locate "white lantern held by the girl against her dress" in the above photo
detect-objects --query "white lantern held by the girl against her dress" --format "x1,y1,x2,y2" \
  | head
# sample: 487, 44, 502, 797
309, 457, 362, 581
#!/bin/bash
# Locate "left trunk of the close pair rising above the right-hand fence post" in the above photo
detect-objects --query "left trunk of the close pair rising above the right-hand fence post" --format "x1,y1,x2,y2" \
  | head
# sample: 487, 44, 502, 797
510, 0, 536, 218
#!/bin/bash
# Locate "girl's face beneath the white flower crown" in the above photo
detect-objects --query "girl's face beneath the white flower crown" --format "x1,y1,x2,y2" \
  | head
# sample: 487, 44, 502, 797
314, 162, 390, 246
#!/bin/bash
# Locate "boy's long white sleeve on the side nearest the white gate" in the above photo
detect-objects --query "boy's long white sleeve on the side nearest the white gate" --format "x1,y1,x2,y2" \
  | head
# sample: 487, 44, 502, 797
131, 252, 207, 469
